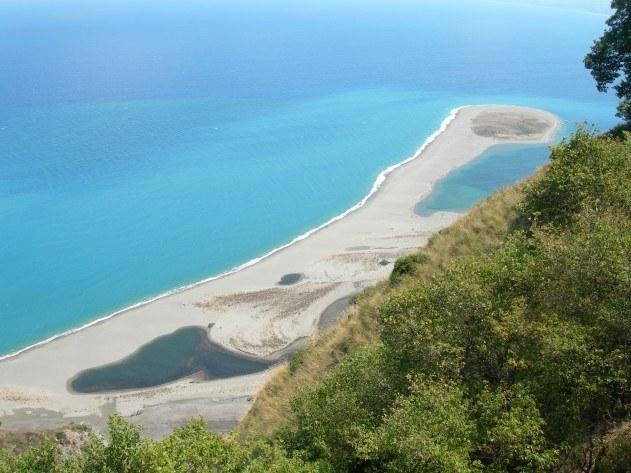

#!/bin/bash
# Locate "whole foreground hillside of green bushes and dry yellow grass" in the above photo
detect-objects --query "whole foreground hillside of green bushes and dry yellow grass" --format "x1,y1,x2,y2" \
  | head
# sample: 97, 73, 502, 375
0, 130, 631, 473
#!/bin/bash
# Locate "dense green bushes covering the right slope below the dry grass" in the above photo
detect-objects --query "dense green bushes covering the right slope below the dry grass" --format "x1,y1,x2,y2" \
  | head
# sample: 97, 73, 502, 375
284, 130, 631, 472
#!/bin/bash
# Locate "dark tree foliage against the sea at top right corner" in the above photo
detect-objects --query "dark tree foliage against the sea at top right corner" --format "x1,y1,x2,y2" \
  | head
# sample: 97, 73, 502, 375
585, 0, 631, 120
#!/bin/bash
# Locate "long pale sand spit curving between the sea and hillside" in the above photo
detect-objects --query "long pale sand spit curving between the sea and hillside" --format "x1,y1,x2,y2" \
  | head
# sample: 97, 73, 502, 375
0, 106, 560, 437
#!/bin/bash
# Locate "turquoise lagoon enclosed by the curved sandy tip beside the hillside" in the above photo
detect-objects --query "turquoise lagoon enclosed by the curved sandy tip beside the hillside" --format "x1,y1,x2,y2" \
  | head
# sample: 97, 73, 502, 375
415, 145, 550, 217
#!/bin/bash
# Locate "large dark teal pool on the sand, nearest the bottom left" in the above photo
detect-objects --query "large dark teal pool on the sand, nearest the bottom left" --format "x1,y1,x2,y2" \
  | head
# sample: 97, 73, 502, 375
69, 327, 272, 393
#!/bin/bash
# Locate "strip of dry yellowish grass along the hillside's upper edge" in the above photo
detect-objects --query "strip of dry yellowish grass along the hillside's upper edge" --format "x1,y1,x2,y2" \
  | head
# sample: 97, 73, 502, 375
235, 182, 522, 439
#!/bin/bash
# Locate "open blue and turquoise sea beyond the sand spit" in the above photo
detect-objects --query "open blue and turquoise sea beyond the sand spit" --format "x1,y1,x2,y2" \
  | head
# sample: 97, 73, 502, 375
0, 0, 615, 353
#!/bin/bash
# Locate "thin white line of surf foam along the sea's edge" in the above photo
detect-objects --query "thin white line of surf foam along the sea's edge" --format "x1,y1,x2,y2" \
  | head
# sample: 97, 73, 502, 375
0, 107, 463, 361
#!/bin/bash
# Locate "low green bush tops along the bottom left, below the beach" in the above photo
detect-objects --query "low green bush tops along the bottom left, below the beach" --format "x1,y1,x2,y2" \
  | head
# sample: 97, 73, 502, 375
0, 416, 326, 473
